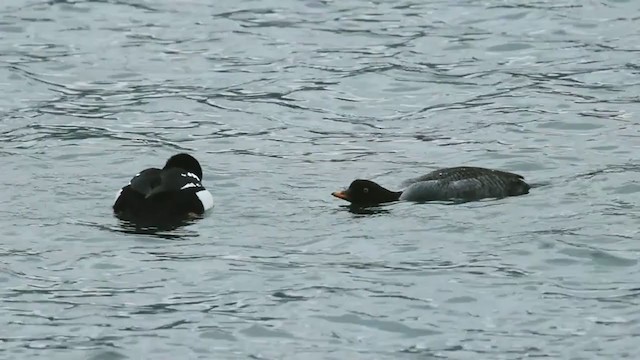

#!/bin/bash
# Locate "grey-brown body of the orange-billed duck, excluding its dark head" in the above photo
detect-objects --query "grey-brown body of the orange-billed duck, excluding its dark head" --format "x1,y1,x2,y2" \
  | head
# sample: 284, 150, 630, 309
400, 166, 530, 201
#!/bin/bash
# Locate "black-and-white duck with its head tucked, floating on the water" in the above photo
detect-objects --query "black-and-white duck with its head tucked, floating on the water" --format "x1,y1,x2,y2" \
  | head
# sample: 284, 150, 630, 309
113, 153, 213, 224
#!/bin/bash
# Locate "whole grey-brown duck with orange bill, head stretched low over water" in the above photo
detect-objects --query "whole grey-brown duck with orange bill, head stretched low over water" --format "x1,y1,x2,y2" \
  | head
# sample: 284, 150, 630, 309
331, 166, 531, 205
